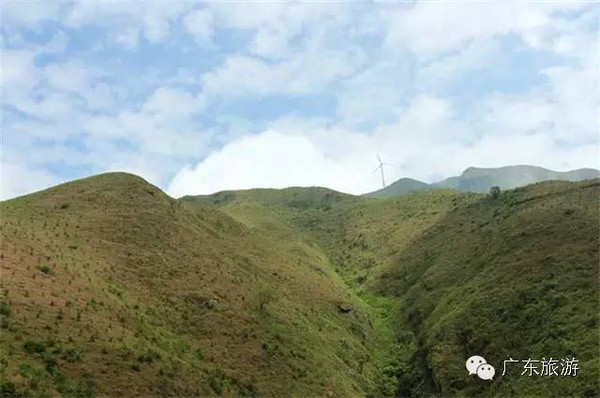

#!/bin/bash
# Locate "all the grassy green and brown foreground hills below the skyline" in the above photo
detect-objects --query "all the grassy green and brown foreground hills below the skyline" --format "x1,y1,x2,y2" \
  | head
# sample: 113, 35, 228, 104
0, 173, 600, 397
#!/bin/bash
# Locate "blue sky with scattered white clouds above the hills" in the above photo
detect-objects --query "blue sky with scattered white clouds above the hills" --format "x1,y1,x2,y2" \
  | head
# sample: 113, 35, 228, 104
0, 0, 600, 199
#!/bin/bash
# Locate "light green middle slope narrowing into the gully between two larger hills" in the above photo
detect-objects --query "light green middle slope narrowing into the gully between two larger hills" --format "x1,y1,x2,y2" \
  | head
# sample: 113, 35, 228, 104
186, 188, 480, 396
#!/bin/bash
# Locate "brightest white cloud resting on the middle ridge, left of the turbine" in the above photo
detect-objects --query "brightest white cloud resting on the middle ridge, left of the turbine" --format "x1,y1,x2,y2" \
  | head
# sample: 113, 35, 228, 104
167, 131, 380, 196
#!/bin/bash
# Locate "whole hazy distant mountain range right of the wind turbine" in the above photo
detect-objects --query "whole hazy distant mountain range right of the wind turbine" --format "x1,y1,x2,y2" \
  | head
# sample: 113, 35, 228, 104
366, 166, 600, 197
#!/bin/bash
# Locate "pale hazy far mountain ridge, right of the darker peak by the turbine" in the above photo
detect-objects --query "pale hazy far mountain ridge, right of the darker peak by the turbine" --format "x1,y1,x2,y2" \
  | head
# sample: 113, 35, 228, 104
431, 166, 600, 193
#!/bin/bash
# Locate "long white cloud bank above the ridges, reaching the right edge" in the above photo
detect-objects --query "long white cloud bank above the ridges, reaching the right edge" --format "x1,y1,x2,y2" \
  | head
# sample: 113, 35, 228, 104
168, 87, 599, 196
